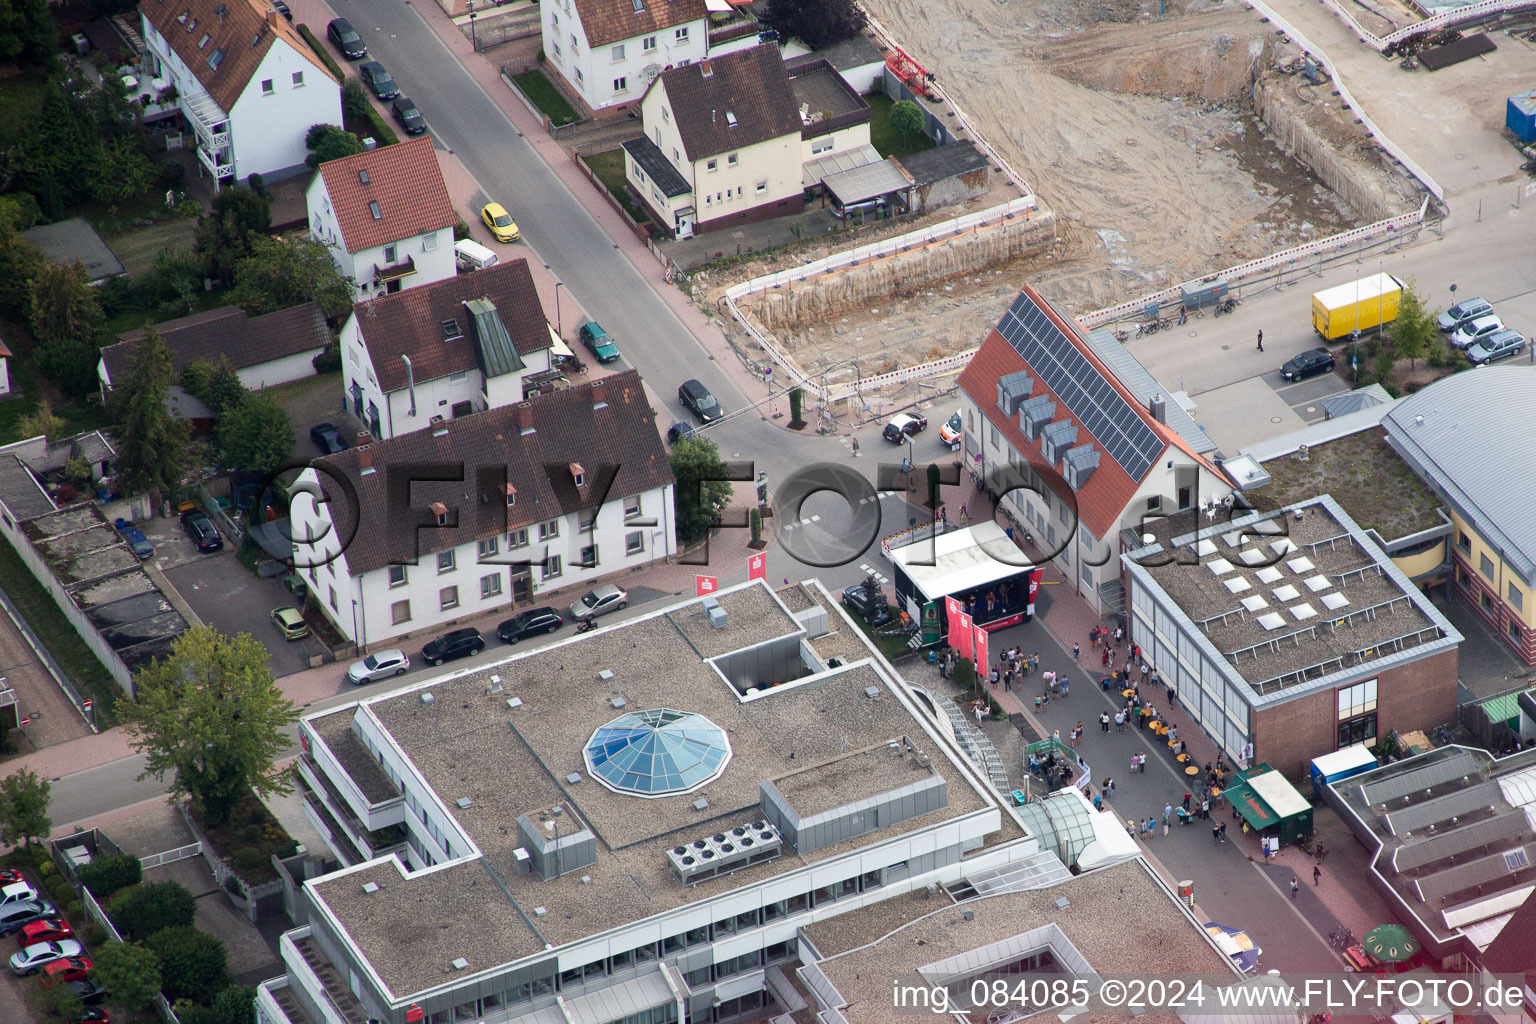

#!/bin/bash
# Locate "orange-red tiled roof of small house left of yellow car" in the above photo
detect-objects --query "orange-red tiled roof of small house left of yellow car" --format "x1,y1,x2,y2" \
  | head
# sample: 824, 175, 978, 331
319, 135, 459, 252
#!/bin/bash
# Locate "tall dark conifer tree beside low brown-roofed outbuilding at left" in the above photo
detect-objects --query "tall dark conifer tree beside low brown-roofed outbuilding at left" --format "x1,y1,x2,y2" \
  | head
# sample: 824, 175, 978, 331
112, 327, 189, 494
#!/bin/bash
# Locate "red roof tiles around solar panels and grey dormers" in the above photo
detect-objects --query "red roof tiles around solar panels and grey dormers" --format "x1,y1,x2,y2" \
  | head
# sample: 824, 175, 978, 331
960, 286, 1206, 540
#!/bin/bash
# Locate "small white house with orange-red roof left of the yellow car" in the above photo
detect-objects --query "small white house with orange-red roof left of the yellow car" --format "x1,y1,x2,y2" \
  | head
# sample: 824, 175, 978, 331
304, 137, 459, 301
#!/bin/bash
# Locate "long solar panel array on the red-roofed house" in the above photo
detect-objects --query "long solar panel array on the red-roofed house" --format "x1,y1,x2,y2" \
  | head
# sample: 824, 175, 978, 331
997, 293, 1164, 481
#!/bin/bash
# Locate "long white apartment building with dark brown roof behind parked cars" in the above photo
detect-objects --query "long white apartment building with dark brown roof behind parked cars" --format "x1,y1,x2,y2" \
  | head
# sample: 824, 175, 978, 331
290, 370, 677, 648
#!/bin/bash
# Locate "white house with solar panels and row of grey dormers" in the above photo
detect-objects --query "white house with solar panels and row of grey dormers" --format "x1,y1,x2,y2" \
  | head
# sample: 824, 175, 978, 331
951, 287, 1233, 614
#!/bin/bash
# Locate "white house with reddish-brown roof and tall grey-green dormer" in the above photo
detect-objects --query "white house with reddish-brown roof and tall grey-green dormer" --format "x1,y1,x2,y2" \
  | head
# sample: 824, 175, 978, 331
341, 259, 559, 439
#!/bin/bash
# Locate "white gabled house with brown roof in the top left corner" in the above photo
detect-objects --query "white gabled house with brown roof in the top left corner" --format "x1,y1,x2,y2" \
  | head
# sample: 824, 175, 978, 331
138, 0, 341, 184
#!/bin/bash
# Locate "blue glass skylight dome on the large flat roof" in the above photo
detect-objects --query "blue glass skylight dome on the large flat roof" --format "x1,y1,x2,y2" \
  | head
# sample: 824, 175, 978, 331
582, 708, 731, 797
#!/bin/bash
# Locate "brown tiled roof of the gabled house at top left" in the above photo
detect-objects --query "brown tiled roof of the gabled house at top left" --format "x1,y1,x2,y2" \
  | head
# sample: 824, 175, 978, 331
138, 0, 341, 114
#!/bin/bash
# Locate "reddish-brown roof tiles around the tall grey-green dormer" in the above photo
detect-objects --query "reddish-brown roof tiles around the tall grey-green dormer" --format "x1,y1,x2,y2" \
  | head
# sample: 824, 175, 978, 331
352, 259, 551, 391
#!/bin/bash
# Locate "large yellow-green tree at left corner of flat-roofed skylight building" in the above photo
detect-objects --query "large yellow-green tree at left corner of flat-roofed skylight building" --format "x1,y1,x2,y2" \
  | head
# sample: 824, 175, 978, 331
118, 626, 296, 826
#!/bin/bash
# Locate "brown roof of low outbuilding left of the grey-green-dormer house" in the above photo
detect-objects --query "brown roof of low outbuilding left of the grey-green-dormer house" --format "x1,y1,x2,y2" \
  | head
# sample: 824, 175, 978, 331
101, 302, 332, 384
